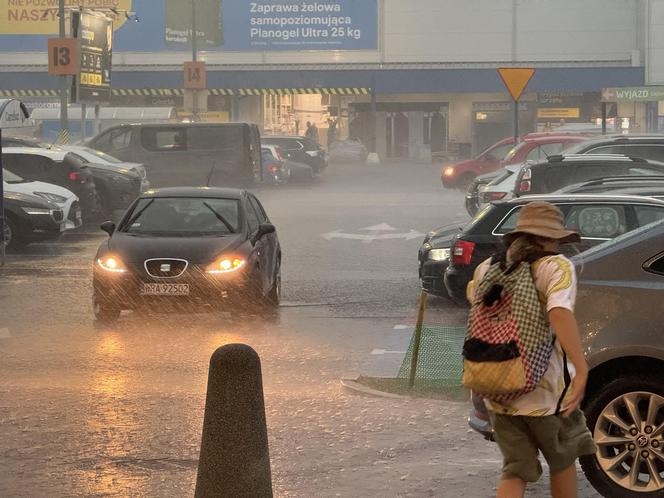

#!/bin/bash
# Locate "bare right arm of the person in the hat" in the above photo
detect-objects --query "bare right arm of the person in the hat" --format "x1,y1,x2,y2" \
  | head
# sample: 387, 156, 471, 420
549, 308, 588, 417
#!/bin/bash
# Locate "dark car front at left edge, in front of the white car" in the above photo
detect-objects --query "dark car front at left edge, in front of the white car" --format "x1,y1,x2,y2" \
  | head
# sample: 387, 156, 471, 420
0, 192, 65, 251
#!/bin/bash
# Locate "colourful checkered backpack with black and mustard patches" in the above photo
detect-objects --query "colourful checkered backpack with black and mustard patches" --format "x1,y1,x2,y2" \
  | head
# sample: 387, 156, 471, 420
463, 253, 554, 403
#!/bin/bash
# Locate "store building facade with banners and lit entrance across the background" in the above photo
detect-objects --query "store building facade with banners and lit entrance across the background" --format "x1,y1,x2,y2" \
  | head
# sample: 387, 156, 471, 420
0, 0, 664, 159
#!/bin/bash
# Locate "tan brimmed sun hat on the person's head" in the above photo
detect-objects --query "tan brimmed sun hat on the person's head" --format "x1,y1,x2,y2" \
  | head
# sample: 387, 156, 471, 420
505, 201, 581, 244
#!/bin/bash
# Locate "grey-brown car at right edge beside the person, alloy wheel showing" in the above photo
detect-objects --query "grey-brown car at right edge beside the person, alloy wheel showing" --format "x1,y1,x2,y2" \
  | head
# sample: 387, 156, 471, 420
469, 221, 664, 498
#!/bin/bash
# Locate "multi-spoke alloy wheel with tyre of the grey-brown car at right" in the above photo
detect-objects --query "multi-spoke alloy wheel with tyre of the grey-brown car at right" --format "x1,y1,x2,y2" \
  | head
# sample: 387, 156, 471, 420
580, 374, 664, 498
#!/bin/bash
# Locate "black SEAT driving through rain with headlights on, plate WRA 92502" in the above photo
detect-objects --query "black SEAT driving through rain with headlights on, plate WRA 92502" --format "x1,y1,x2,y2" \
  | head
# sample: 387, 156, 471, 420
93, 187, 281, 323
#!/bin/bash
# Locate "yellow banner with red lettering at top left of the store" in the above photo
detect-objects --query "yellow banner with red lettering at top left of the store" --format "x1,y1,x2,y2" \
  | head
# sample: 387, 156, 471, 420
0, 0, 131, 34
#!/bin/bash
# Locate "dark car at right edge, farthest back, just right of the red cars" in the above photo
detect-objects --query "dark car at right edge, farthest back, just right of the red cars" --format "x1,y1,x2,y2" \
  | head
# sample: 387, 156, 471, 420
566, 135, 664, 162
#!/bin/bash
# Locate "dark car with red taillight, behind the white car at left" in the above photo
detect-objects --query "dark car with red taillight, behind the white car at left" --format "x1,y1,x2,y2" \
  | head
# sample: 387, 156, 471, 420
2, 147, 100, 218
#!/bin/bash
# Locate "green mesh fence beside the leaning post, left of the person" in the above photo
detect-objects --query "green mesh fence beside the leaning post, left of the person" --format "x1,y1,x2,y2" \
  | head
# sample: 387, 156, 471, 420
399, 325, 466, 391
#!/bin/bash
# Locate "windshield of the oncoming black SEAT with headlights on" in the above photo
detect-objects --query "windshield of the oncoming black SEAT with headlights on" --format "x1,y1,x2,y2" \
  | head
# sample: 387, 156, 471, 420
120, 197, 240, 237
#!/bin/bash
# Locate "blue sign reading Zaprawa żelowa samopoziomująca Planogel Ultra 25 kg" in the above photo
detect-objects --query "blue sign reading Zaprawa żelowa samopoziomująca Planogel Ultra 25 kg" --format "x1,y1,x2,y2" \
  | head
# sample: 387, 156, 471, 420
222, 0, 378, 51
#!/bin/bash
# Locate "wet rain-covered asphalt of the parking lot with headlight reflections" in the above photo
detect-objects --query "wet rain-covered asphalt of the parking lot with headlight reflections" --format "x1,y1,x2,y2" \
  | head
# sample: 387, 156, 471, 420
0, 163, 597, 497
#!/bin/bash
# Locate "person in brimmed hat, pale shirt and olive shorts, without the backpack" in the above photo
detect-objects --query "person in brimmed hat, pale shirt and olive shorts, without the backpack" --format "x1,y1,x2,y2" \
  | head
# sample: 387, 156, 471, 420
468, 201, 597, 498
